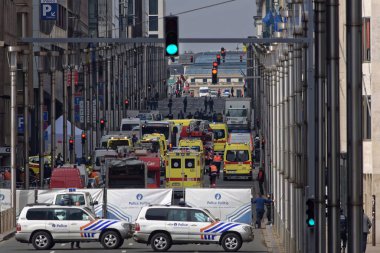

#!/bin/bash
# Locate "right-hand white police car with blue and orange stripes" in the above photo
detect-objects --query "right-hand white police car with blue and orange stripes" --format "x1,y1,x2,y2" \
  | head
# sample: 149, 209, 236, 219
133, 206, 254, 251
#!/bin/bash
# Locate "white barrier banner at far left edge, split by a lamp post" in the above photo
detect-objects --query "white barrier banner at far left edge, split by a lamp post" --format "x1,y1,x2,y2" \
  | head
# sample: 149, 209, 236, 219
0, 189, 34, 215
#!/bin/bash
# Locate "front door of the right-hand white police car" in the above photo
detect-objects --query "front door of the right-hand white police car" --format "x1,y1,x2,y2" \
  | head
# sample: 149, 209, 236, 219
188, 210, 221, 242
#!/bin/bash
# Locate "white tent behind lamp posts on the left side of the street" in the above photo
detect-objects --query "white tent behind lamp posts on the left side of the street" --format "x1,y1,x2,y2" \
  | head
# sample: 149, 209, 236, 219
44, 116, 83, 157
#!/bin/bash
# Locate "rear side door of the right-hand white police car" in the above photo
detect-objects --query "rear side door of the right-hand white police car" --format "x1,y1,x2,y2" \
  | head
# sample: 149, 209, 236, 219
165, 208, 189, 242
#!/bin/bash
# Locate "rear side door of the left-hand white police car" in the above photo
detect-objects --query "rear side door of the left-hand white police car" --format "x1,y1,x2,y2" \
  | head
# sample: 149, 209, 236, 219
46, 208, 70, 240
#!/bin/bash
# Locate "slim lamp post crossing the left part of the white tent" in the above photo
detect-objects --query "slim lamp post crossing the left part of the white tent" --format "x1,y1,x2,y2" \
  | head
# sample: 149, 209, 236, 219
49, 51, 59, 169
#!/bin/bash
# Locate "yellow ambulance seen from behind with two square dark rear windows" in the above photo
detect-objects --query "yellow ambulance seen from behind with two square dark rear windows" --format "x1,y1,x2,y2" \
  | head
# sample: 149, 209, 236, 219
165, 147, 203, 190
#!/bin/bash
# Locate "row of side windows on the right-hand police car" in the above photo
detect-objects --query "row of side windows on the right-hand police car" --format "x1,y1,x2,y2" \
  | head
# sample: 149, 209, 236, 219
145, 208, 209, 222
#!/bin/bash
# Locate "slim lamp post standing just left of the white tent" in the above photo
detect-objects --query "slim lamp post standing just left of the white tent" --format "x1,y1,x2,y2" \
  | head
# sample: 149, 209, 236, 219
34, 51, 47, 189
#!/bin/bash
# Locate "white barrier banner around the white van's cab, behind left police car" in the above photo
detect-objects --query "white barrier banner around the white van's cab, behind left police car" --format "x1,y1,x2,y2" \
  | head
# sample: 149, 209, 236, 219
37, 189, 103, 217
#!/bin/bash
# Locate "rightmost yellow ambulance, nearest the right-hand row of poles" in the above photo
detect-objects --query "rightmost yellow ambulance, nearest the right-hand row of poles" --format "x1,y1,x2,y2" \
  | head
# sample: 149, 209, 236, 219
223, 143, 252, 180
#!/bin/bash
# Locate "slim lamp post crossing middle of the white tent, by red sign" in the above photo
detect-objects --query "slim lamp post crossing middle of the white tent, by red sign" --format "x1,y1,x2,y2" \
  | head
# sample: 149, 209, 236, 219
62, 50, 71, 163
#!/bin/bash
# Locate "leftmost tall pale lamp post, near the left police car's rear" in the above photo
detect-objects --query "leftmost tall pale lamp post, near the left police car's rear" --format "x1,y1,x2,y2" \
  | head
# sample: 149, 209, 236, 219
7, 46, 20, 226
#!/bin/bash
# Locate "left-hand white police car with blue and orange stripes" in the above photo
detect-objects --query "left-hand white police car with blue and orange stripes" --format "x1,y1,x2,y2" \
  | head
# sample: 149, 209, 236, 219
15, 204, 133, 250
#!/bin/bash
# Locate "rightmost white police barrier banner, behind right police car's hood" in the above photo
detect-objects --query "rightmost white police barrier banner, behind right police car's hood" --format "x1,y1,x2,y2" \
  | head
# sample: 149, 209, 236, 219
185, 188, 252, 224
